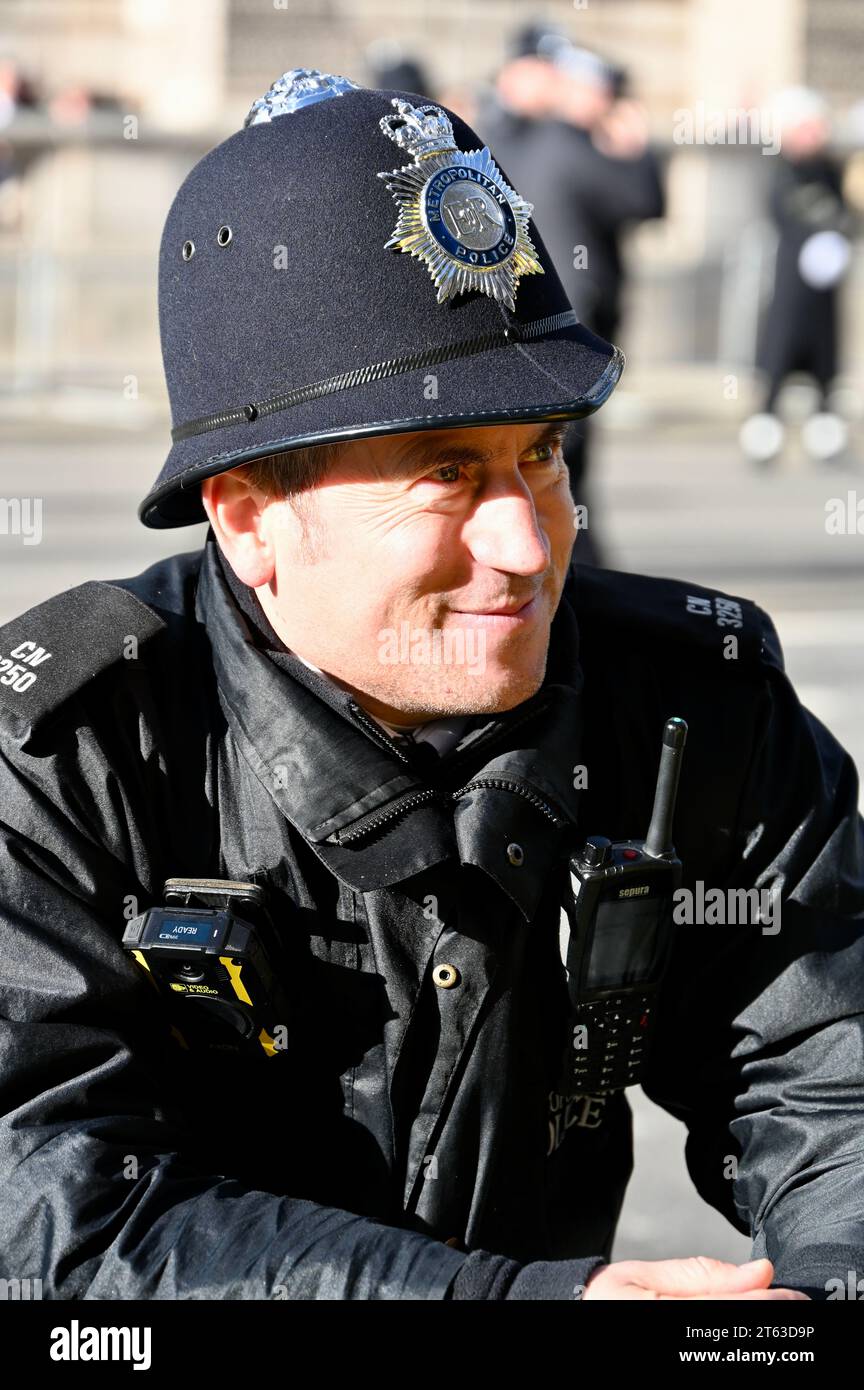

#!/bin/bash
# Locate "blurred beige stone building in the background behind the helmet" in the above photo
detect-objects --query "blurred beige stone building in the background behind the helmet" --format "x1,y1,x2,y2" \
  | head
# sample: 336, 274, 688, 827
0, 0, 864, 405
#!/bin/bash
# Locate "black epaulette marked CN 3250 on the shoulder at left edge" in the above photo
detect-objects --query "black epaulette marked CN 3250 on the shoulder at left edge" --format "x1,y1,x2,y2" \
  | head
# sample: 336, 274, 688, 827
0, 552, 200, 746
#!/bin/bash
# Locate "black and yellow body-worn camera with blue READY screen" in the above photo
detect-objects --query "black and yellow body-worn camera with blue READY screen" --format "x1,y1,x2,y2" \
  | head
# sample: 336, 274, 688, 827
122, 878, 289, 1056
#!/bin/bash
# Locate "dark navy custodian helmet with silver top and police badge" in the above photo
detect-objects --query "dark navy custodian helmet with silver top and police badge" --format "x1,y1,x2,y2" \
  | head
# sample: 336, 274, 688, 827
139, 68, 624, 527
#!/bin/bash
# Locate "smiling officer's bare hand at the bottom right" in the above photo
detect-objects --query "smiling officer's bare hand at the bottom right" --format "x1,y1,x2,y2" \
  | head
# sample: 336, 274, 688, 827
582, 1255, 810, 1302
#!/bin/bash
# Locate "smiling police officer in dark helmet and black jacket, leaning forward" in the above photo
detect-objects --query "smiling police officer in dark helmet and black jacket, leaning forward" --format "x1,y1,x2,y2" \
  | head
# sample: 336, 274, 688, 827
0, 71, 864, 1300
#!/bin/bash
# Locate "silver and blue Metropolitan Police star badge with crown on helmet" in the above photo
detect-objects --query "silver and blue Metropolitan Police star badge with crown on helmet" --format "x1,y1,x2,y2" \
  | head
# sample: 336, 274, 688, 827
378, 97, 545, 310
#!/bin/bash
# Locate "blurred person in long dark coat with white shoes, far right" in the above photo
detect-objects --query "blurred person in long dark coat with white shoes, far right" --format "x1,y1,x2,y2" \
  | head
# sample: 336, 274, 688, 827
740, 88, 854, 466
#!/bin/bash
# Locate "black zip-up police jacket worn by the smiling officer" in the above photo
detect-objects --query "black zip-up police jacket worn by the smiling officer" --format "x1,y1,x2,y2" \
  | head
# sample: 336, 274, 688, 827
0, 532, 864, 1298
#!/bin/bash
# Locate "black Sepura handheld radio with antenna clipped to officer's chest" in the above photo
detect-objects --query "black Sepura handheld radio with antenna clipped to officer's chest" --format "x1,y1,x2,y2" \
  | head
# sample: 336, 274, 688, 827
558, 717, 688, 1095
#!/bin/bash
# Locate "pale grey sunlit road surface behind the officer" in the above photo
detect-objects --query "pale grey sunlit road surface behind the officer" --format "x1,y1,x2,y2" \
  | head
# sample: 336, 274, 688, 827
0, 405, 864, 1259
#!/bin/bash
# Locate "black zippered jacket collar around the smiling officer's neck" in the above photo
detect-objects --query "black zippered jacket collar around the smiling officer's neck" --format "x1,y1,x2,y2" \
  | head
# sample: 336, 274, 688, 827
196, 531, 582, 920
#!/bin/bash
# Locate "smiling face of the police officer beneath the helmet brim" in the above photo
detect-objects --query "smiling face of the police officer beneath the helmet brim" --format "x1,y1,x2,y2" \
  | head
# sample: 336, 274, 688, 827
203, 421, 575, 724
